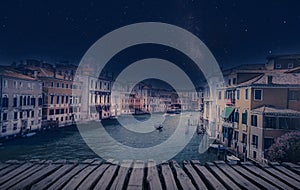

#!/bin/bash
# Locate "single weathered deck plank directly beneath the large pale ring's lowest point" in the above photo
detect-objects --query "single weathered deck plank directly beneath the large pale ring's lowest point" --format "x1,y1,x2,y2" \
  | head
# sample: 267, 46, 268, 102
146, 160, 162, 190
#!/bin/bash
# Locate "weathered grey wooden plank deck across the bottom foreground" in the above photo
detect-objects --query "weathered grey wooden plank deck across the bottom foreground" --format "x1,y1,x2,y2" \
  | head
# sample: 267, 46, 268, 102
0, 159, 300, 190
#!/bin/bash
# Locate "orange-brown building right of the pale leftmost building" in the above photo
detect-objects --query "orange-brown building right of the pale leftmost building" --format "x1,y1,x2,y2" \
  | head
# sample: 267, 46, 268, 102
19, 65, 81, 127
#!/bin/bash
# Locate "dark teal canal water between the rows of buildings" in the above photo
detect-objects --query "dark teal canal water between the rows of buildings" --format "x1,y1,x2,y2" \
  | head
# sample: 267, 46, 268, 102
0, 115, 217, 162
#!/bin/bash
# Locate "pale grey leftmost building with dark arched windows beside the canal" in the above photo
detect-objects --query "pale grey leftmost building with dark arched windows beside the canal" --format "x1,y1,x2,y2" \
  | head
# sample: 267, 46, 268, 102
0, 67, 43, 137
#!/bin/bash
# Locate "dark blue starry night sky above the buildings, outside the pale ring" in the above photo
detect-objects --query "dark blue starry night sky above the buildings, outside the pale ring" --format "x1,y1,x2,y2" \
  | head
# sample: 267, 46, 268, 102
0, 0, 300, 67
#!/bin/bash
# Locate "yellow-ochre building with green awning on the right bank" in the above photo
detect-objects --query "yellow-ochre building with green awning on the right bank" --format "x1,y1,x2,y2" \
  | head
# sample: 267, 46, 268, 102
215, 56, 300, 161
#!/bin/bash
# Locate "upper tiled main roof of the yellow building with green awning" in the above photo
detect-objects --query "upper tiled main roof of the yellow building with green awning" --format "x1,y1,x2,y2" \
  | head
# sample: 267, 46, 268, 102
238, 71, 300, 86
